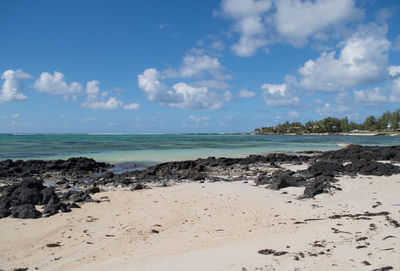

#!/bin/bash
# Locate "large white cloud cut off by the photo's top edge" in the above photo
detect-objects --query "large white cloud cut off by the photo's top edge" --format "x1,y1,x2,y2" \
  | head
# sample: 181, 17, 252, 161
217, 0, 364, 57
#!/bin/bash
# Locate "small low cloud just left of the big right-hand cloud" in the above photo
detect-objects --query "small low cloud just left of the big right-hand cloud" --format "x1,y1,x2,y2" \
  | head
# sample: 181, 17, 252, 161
261, 84, 300, 107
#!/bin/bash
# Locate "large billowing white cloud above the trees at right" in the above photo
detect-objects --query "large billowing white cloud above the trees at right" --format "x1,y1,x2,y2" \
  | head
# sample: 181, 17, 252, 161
299, 24, 390, 92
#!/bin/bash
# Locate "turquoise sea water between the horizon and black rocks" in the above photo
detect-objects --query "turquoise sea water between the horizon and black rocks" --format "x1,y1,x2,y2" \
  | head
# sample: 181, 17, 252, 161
0, 134, 400, 164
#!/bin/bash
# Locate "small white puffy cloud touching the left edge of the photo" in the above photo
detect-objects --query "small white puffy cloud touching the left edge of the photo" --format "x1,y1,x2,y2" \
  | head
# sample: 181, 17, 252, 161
0, 70, 31, 103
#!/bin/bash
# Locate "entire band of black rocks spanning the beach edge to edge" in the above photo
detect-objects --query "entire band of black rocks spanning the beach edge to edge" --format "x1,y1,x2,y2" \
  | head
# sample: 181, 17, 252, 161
0, 145, 400, 218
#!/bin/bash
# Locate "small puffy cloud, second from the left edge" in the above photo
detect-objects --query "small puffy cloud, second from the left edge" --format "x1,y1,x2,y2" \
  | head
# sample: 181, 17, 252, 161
34, 71, 82, 99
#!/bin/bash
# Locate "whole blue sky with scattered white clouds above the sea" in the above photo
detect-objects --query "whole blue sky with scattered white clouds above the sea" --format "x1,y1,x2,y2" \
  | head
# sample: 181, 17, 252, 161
0, 0, 400, 133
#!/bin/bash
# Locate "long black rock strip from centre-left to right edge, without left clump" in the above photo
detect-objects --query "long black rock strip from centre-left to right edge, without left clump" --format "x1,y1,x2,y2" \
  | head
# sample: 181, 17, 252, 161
95, 145, 400, 201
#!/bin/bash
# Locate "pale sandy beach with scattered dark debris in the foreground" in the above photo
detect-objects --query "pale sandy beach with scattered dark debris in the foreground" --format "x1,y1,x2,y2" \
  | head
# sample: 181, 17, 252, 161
0, 176, 400, 271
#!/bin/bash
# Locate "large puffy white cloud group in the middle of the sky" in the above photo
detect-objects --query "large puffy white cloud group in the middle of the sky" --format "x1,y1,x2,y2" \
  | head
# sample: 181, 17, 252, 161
138, 50, 233, 110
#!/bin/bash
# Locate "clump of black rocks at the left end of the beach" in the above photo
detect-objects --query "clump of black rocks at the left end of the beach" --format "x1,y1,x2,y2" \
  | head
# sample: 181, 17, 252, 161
0, 157, 112, 218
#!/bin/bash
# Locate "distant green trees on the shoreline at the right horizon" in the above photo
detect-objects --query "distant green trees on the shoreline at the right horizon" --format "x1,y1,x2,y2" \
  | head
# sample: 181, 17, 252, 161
255, 109, 400, 134
